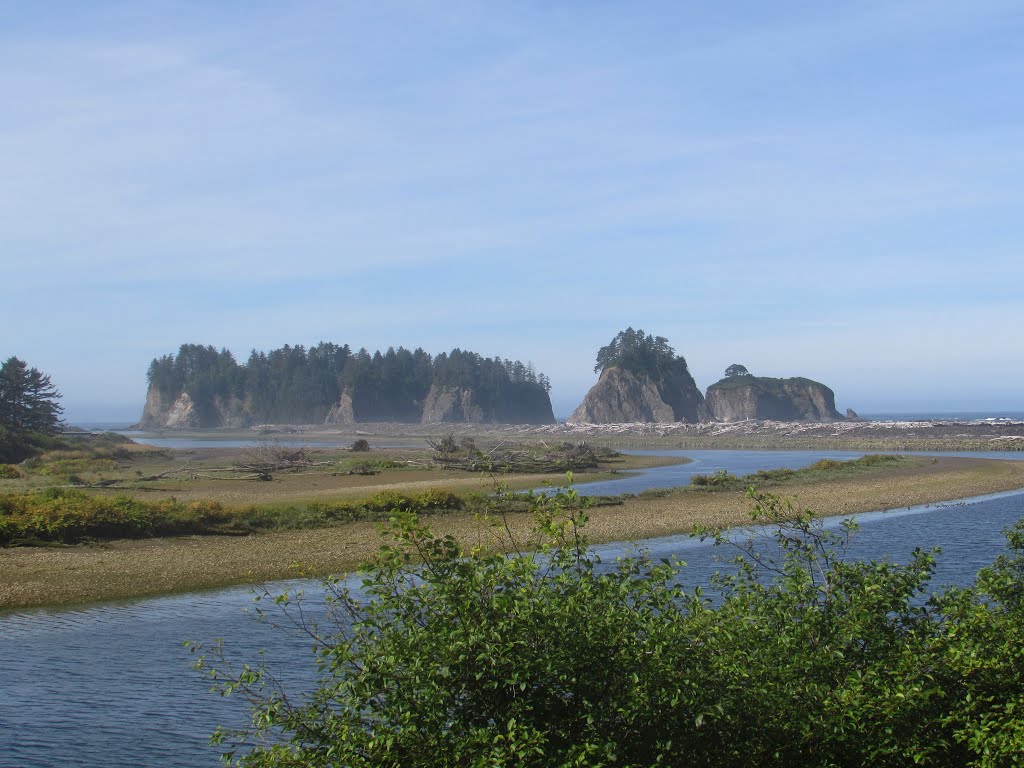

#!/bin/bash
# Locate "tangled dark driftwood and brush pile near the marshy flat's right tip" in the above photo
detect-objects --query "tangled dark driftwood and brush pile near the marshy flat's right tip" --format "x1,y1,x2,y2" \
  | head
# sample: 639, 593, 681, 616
427, 433, 618, 474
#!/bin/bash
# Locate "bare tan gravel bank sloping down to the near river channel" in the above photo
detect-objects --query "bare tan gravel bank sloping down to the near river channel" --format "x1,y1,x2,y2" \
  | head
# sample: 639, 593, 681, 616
0, 458, 1024, 609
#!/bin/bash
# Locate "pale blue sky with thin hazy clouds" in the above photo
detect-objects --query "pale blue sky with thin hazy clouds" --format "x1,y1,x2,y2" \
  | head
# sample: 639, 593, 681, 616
0, 0, 1024, 421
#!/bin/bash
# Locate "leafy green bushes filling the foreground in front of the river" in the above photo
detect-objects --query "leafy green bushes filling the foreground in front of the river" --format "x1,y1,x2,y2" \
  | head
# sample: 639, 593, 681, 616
194, 492, 1024, 768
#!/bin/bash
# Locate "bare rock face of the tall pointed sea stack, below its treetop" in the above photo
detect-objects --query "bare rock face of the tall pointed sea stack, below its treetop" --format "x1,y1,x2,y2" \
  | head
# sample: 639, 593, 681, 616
568, 368, 703, 424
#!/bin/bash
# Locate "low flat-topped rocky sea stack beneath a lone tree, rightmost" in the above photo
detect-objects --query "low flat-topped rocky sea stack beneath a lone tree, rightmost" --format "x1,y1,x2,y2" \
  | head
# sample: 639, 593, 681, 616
705, 376, 843, 422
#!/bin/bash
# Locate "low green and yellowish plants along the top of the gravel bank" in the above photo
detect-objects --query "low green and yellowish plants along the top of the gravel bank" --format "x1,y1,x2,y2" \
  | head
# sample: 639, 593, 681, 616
0, 456, 905, 547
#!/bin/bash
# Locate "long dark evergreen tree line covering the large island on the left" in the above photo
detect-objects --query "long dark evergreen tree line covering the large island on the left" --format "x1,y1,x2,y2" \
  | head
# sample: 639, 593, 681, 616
147, 342, 551, 425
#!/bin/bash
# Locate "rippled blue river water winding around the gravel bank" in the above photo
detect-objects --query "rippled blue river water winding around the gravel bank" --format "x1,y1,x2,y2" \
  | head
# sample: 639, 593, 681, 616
0, 451, 1024, 768
